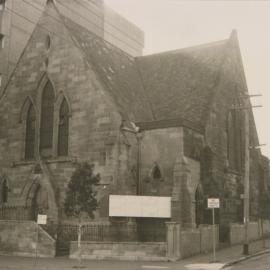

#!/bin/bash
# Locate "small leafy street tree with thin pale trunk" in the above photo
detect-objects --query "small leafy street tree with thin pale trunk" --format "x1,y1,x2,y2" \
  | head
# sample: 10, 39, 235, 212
64, 162, 100, 266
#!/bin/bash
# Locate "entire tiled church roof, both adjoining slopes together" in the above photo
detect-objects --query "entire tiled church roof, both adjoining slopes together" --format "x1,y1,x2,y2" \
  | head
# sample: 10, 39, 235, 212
65, 18, 228, 127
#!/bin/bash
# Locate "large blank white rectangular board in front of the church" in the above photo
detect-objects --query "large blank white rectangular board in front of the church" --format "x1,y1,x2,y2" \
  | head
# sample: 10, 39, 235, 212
109, 195, 171, 218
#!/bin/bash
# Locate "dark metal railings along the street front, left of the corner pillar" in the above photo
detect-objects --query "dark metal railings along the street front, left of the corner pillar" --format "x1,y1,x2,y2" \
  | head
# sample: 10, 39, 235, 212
0, 206, 167, 242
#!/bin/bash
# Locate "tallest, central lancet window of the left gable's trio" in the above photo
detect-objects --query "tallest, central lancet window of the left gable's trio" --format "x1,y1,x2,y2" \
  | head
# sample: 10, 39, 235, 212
40, 81, 55, 157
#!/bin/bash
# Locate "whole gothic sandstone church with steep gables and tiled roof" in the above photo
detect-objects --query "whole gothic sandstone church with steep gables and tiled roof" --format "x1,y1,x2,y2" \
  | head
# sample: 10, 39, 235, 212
0, 1, 269, 240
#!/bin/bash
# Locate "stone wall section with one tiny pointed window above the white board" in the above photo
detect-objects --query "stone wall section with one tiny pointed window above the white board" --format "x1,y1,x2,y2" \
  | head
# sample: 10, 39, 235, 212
138, 128, 181, 196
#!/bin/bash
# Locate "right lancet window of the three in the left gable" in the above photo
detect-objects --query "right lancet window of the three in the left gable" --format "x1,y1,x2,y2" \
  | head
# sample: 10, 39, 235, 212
58, 99, 69, 156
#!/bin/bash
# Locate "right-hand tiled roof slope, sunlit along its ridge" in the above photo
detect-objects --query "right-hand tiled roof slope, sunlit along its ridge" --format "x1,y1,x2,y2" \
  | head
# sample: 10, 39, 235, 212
137, 40, 227, 124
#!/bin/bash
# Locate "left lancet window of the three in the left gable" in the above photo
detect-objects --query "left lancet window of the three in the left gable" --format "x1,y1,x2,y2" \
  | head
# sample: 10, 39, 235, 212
25, 104, 36, 160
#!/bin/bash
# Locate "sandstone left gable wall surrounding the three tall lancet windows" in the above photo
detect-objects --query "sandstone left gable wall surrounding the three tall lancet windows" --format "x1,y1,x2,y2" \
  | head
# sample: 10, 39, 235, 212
0, 4, 124, 223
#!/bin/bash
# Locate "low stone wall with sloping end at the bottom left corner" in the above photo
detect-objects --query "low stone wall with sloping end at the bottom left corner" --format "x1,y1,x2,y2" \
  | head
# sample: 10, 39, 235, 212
0, 220, 55, 257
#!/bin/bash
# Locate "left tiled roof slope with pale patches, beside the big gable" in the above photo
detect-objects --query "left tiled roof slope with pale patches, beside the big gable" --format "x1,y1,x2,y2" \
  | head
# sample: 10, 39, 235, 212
65, 18, 153, 121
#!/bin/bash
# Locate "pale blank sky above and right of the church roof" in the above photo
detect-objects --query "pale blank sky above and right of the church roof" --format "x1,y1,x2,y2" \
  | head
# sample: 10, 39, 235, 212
105, 0, 270, 158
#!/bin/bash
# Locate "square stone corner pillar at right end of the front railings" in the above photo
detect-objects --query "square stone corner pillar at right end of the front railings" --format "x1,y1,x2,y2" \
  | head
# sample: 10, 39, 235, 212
166, 222, 181, 259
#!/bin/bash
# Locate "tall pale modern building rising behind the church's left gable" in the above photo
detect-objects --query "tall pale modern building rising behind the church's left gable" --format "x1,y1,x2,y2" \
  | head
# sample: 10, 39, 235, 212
0, 0, 144, 94
